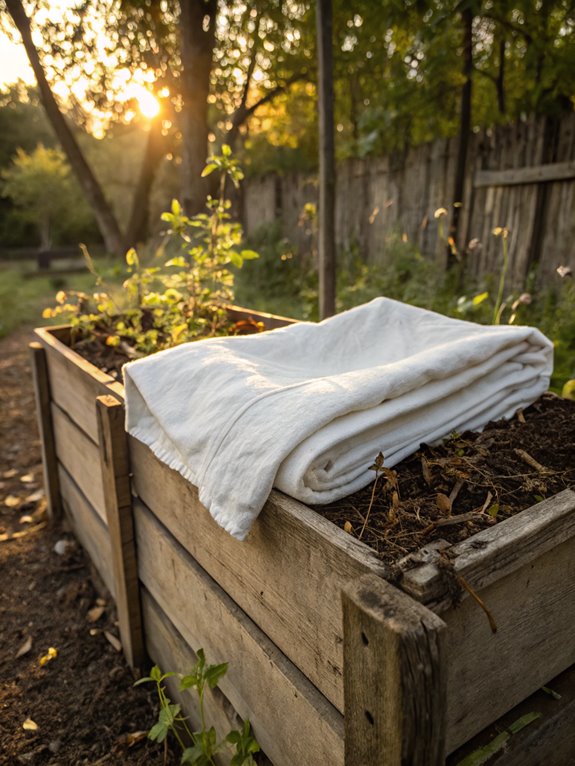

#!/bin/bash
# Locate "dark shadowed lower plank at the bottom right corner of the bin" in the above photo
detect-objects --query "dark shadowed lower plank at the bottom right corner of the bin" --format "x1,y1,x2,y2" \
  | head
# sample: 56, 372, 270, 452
446, 666, 575, 766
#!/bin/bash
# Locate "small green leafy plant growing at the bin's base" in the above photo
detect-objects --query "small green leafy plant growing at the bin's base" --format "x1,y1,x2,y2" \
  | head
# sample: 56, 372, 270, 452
135, 649, 260, 766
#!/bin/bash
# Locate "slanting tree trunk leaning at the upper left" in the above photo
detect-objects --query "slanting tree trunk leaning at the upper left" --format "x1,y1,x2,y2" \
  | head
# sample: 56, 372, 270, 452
6, 0, 124, 254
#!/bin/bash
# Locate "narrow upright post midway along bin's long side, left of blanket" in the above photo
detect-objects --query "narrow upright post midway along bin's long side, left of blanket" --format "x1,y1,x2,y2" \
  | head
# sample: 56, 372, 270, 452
96, 395, 145, 668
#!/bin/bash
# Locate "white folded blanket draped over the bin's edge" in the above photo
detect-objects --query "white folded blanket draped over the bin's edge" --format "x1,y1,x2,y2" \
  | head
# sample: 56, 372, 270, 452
124, 298, 553, 540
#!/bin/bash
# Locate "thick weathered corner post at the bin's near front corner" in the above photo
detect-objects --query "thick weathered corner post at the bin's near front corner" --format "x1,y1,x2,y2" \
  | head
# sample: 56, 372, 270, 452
342, 575, 446, 766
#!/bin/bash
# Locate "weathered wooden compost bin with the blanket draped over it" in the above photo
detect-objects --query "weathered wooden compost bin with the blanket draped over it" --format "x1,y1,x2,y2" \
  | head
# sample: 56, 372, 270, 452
32, 312, 575, 766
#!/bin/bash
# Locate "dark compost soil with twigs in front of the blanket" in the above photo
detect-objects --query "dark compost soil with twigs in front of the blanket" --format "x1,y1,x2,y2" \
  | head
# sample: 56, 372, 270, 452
315, 394, 575, 564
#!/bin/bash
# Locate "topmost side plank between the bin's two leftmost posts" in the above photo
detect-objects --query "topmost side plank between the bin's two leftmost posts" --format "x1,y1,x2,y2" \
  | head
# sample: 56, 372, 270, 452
35, 328, 124, 442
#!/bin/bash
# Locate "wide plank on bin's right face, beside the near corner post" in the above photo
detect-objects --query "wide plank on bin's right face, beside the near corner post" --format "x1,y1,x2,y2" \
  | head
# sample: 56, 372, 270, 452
441, 537, 575, 752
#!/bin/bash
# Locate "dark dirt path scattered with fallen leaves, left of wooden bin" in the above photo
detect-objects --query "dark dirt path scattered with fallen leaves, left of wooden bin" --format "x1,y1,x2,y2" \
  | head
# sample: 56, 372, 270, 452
0, 332, 171, 766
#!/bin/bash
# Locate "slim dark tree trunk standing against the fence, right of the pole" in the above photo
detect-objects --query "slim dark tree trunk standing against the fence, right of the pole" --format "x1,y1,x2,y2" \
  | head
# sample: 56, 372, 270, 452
447, 8, 473, 266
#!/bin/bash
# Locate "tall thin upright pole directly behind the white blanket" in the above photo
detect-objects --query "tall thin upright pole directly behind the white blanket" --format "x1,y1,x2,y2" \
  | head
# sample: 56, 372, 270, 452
316, 0, 335, 319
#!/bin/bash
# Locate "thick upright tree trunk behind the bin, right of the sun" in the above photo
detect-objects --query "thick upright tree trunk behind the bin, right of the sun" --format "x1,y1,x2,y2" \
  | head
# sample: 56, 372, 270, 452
180, 0, 217, 215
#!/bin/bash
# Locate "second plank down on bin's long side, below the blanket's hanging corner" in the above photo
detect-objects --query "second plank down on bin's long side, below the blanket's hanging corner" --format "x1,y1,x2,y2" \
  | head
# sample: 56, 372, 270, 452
134, 501, 343, 766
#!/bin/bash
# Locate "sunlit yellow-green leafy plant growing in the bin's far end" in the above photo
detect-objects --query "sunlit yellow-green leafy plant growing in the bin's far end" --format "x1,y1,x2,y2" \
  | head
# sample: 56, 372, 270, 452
43, 145, 259, 366
